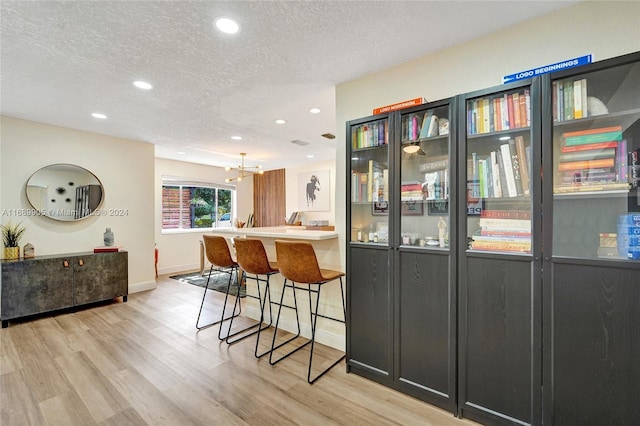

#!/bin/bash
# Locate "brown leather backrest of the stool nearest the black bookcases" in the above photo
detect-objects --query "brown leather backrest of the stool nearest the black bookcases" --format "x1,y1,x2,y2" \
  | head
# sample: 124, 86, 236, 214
275, 240, 324, 283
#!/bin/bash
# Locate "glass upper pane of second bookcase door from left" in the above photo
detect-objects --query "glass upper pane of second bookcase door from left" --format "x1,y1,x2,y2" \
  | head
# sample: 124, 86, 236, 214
400, 105, 451, 248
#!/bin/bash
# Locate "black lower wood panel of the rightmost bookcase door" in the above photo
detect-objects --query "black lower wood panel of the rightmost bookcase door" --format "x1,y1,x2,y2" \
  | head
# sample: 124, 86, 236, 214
549, 263, 640, 425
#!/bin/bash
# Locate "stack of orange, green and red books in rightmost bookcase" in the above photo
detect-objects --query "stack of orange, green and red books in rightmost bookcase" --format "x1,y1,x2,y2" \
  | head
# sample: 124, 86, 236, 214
554, 126, 629, 193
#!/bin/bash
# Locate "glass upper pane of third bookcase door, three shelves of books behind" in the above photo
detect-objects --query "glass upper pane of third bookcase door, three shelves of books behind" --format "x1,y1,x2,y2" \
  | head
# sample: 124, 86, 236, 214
466, 86, 535, 253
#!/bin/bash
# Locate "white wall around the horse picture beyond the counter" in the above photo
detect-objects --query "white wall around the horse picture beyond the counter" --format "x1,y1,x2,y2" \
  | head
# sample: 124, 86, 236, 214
285, 161, 336, 225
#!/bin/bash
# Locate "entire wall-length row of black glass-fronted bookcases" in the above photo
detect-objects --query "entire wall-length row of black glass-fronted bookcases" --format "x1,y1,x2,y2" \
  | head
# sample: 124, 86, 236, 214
347, 52, 640, 424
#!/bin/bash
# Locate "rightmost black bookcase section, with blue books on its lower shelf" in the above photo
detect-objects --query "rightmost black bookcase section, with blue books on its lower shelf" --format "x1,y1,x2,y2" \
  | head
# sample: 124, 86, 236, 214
542, 53, 640, 424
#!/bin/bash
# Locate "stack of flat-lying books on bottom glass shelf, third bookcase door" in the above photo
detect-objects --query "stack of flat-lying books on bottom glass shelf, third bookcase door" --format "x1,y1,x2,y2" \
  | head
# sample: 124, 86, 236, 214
470, 209, 531, 253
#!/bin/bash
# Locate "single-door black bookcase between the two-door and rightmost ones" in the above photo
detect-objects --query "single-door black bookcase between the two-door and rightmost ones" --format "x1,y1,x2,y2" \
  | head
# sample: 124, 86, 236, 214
457, 79, 542, 424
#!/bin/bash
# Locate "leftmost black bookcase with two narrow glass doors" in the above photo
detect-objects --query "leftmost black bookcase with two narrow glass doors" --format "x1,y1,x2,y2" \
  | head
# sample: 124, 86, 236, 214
347, 99, 457, 412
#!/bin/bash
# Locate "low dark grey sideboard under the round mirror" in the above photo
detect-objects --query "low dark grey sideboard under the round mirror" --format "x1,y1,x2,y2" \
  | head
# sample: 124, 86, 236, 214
1, 252, 128, 327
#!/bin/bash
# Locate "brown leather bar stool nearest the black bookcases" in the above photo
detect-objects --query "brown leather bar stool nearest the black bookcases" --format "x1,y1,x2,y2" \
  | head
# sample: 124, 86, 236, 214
269, 240, 346, 384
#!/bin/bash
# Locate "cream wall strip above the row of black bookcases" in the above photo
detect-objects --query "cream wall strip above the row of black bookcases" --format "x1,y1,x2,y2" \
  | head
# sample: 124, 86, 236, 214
335, 1, 640, 259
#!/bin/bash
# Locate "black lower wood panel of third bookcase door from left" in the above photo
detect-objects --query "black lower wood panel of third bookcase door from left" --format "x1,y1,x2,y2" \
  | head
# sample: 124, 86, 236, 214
460, 257, 534, 423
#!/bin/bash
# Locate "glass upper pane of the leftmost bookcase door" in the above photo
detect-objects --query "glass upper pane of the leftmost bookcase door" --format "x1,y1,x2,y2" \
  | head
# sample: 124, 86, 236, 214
350, 117, 390, 245
